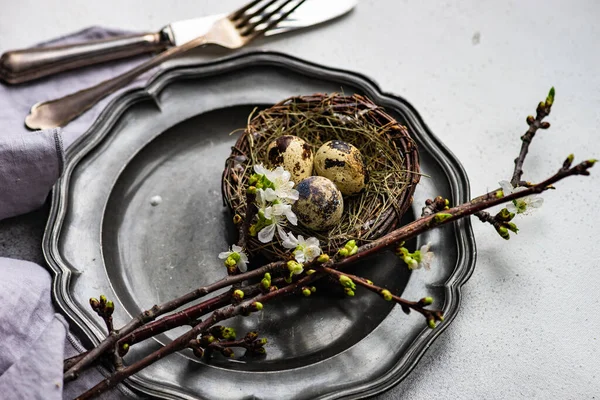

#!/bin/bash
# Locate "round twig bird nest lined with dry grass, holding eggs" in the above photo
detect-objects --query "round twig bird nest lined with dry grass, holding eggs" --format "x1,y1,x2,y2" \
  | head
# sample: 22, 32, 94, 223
222, 94, 420, 259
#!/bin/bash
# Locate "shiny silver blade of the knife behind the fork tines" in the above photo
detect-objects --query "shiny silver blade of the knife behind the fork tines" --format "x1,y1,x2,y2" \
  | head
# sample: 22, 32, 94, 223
161, 0, 358, 46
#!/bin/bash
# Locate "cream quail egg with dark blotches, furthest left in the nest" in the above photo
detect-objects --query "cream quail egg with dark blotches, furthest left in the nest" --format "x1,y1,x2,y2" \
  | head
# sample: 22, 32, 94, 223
266, 135, 313, 183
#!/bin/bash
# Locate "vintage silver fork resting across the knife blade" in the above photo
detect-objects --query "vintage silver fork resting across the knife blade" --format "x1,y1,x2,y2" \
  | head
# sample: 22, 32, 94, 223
25, 0, 305, 129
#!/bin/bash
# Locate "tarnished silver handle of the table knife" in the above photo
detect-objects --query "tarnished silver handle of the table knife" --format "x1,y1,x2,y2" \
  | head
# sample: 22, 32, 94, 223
0, 33, 169, 84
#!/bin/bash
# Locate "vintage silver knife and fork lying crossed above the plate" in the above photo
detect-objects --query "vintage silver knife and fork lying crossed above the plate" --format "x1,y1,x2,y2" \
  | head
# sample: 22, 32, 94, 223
0, 0, 357, 130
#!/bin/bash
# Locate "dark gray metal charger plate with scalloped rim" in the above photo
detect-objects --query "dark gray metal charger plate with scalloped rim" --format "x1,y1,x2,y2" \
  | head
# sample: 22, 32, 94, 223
43, 52, 476, 399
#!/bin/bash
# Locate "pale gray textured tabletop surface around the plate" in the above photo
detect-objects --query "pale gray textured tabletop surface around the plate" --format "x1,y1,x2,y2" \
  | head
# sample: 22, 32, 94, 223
0, 0, 600, 399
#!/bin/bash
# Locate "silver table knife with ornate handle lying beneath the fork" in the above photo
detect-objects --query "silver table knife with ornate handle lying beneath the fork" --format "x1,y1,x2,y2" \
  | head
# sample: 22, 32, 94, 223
0, 0, 358, 84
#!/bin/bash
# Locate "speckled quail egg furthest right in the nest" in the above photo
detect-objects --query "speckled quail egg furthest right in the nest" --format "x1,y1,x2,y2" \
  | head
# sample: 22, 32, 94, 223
314, 140, 369, 196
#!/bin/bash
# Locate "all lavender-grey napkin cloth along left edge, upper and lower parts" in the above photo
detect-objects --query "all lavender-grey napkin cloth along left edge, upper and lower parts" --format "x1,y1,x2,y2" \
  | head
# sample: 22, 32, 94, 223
0, 27, 157, 400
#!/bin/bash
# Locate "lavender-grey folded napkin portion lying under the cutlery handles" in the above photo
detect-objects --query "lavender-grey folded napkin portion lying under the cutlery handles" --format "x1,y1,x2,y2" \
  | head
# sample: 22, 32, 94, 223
0, 27, 157, 220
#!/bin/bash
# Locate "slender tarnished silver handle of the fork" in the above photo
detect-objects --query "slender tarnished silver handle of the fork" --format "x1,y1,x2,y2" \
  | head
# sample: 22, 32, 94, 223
25, 36, 208, 130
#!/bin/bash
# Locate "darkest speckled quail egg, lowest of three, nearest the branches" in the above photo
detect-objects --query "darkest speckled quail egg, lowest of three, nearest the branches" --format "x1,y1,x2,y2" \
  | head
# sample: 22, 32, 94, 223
292, 176, 344, 231
